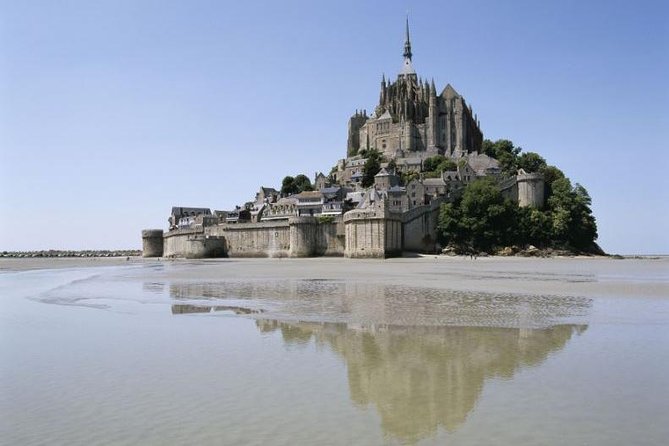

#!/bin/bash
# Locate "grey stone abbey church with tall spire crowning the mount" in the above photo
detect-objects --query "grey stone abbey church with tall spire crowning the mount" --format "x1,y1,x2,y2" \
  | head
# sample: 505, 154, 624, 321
347, 20, 483, 158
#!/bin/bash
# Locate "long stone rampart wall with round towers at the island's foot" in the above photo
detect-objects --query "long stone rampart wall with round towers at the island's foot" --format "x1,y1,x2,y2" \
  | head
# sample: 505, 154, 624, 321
148, 199, 441, 259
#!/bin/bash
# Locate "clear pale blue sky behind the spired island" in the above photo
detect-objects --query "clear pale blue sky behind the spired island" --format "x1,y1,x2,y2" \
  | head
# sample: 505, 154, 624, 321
0, 0, 669, 254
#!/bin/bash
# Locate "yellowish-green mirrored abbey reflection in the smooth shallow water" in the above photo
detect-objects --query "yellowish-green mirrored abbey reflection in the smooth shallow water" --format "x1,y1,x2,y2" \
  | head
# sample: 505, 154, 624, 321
256, 320, 587, 443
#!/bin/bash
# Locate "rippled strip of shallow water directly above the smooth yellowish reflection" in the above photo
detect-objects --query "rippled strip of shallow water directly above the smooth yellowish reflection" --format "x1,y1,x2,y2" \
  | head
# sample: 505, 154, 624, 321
169, 279, 591, 328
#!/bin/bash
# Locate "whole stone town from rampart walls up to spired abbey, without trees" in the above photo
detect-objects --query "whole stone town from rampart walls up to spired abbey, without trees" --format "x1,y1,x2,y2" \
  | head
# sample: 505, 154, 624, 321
142, 21, 544, 258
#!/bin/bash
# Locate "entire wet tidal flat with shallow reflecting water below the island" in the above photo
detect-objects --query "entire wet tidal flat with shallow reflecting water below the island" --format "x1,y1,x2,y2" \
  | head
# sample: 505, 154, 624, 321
0, 256, 669, 445
